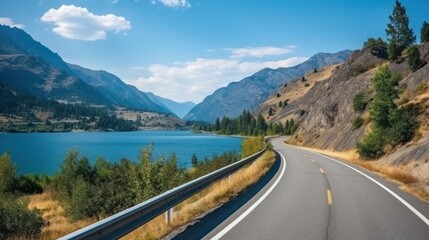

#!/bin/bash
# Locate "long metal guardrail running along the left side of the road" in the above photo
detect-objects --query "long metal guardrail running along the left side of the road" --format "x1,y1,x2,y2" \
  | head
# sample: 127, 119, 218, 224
60, 145, 267, 240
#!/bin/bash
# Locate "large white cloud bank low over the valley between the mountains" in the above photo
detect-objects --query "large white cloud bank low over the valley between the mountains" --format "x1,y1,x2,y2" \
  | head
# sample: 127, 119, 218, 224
127, 57, 308, 103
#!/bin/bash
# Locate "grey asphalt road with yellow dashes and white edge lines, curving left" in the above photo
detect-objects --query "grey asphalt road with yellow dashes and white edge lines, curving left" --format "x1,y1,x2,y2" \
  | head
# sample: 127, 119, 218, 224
177, 139, 429, 240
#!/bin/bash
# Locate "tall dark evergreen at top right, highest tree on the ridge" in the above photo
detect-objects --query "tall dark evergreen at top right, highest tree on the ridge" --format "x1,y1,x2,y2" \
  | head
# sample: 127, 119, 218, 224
386, 0, 416, 52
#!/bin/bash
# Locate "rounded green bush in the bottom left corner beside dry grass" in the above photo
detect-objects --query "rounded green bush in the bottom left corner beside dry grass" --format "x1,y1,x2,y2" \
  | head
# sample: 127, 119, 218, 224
0, 194, 46, 239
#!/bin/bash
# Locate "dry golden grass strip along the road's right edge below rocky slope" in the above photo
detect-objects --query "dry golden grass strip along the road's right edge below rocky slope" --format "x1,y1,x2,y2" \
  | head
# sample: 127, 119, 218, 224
294, 147, 429, 202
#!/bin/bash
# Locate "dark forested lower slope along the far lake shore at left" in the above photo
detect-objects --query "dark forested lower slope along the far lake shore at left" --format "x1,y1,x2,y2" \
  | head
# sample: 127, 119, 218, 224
0, 85, 138, 132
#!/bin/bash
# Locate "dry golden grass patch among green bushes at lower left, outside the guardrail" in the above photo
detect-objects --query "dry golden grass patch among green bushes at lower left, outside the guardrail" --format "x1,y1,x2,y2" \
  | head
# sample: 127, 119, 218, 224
28, 191, 95, 239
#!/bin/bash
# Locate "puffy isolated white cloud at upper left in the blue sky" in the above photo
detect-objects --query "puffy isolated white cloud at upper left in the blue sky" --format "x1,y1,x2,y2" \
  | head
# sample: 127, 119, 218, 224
41, 5, 131, 41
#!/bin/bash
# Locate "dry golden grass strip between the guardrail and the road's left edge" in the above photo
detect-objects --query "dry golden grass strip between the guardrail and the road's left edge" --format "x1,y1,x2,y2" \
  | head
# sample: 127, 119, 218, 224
119, 151, 275, 239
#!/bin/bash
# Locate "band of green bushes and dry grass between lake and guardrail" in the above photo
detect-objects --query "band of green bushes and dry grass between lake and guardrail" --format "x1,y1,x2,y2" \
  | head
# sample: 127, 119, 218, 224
0, 137, 264, 239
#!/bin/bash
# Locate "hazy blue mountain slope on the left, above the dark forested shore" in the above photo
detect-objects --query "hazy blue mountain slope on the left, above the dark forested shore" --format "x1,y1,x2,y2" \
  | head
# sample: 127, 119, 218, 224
0, 25, 183, 116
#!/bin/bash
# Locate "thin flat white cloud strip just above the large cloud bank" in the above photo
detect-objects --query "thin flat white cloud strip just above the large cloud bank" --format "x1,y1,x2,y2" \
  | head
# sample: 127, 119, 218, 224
225, 46, 294, 58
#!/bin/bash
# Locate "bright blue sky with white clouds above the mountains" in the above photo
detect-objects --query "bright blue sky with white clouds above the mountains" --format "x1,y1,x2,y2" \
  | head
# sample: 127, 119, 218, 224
0, 0, 429, 103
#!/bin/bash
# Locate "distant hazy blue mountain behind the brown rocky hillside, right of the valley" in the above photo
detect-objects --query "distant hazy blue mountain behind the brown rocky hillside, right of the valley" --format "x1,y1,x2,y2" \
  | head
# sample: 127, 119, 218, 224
184, 50, 351, 122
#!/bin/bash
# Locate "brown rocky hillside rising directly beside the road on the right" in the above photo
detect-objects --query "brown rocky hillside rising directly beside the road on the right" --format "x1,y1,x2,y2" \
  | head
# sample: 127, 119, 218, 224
254, 43, 429, 185
